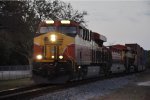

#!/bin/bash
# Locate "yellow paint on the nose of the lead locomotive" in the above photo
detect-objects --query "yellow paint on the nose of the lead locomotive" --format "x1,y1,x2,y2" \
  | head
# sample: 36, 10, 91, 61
34, 32, 75, 62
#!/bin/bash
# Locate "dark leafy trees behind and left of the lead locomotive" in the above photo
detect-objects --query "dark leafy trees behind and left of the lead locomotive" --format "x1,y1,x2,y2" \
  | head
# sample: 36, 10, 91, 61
0, 0, 87, 64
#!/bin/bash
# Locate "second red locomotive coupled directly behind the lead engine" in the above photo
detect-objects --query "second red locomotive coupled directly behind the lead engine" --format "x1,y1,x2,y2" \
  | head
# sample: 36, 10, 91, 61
109, 44, 136, 73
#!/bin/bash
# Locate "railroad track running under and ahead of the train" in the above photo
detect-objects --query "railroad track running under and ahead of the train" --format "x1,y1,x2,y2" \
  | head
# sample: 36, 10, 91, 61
0, 74, 138, 100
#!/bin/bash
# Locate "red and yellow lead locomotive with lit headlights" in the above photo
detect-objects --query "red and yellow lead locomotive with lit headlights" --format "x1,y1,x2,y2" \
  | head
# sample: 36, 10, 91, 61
33, 20, 111, 81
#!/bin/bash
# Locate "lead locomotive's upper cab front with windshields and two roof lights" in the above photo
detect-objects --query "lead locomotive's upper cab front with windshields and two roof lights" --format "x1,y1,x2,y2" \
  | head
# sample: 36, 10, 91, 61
37, 20, 77, 37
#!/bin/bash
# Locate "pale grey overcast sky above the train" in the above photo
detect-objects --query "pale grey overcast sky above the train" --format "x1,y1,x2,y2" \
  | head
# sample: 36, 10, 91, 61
62, 0, 150, 50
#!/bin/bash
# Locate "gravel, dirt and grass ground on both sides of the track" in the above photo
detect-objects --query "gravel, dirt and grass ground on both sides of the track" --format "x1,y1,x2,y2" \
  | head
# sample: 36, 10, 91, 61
0, 69, 150, 100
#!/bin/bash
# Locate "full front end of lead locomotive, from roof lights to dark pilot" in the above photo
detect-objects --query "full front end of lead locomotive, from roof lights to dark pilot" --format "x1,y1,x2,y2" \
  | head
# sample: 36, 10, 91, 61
33, 20, 81, 83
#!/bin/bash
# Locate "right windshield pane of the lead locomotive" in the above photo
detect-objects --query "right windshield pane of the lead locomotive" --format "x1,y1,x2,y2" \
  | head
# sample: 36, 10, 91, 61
59, 26, 77, 36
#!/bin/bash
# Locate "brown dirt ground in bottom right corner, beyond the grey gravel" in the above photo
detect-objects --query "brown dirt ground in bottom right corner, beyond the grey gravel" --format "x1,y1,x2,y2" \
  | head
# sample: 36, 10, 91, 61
90, 71, 150, 100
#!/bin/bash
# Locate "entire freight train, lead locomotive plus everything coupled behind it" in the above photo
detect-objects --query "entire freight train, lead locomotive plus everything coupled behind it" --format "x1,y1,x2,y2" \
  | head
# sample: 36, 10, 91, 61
33, 20, 146, 81
